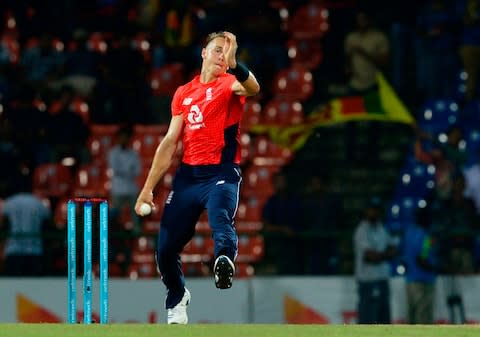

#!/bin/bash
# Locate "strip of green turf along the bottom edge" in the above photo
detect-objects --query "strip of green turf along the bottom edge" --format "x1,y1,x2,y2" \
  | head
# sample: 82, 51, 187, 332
0, 324, 480, 337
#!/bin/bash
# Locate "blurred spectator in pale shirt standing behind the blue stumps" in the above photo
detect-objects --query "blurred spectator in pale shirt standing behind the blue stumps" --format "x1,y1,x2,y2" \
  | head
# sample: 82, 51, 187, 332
108, 126, 142, 233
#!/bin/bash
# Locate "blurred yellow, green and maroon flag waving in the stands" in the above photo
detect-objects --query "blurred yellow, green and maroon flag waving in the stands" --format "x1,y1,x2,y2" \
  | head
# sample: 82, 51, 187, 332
251, 73, 415, 150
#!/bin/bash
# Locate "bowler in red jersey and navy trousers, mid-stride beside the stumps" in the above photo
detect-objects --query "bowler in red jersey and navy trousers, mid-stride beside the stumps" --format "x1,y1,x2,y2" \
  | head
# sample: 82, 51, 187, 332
135, 32, 260, 324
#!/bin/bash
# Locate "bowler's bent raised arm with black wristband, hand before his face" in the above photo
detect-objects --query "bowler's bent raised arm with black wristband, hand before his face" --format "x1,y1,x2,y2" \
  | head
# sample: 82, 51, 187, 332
223, 32, 260, 96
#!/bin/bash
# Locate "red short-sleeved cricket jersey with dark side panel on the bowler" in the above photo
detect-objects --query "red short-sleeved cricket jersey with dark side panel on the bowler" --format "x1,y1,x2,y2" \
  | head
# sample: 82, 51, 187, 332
172, 74, 245, 165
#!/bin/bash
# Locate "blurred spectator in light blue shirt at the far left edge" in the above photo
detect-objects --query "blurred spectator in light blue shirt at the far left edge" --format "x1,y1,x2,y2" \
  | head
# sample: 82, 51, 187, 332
0, 177, 51, 276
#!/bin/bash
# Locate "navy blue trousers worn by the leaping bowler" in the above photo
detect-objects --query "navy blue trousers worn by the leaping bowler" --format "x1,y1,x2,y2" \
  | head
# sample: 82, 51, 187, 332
156, 164, 242, 309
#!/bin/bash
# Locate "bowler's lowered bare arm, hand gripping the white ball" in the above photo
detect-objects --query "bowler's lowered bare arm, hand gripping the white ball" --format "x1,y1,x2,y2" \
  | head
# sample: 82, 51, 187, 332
135, 114, 183, 215
